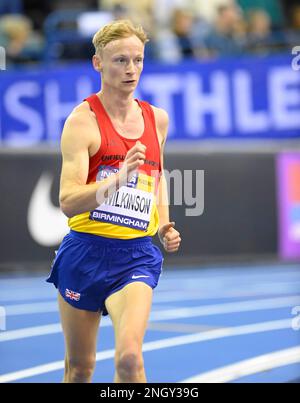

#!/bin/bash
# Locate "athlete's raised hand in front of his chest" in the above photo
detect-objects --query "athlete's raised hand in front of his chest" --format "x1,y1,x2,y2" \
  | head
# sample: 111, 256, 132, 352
119, 141, 146, 184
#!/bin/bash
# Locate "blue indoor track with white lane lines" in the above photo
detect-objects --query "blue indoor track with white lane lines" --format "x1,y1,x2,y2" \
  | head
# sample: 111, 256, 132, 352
0, 264, 300, 383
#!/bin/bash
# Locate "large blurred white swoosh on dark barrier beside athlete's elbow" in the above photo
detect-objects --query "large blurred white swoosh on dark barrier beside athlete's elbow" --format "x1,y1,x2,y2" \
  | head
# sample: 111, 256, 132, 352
27, 172, 69, 246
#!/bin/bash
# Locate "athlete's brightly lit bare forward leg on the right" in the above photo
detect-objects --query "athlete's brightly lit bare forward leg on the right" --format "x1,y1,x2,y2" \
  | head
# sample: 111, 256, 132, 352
105, 282, 152, 382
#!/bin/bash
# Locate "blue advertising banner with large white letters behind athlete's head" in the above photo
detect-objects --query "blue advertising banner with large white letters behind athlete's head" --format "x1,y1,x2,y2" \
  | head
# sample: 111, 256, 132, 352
0, 55, 300, 145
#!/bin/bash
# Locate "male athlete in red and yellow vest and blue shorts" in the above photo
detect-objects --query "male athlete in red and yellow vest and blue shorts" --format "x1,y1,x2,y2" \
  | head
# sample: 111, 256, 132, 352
47, 20, 181, 382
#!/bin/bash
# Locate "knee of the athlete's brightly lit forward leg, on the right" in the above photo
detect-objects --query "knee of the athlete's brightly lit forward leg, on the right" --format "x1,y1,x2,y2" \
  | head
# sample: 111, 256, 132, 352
116, 348, 144, 382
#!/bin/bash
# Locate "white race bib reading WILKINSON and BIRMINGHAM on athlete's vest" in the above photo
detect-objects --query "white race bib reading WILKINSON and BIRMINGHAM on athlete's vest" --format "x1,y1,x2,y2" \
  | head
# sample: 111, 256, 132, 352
90, 166, 154, 231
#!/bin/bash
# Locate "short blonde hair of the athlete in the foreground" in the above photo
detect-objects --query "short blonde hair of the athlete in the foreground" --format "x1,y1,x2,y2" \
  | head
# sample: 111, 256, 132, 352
93, 20, 149, 53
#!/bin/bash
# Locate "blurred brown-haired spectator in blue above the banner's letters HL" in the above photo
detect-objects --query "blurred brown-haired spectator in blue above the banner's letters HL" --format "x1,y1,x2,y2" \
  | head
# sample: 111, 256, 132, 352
194, 4, 246, 57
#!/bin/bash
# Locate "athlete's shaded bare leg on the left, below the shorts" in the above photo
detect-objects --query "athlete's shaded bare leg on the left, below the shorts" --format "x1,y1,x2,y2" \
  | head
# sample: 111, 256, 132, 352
58, 293, 101, 383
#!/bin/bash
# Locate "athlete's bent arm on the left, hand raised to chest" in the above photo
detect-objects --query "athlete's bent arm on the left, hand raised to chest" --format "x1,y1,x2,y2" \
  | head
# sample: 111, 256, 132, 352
59, 111, 145, 217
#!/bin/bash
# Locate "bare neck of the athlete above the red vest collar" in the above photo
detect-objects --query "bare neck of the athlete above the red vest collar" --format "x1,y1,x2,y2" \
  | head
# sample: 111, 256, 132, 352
97, 90, 137, 122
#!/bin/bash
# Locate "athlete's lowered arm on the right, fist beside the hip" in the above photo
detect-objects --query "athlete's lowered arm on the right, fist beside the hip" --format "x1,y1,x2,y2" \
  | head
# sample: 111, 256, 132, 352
153, 107, 181, 252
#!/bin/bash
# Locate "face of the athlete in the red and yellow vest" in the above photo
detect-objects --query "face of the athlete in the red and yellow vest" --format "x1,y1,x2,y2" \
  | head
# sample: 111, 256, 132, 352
94, 35, 144, 92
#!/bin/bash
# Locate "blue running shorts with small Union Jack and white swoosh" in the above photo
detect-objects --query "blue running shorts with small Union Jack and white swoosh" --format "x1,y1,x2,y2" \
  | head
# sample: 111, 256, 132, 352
46, 230, 163, 315
